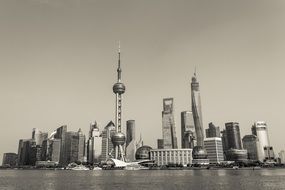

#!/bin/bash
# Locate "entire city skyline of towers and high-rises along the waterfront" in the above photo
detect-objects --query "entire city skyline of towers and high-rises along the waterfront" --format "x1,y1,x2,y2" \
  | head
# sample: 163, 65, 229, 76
2, 51, 285, 167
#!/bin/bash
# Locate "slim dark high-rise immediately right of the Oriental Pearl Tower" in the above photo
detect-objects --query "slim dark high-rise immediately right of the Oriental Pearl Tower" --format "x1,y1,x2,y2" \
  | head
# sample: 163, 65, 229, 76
126, 120, 136, 161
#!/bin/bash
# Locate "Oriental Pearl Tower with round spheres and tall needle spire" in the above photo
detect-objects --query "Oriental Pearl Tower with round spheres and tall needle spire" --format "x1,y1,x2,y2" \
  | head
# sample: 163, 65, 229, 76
112, 45, 126, 161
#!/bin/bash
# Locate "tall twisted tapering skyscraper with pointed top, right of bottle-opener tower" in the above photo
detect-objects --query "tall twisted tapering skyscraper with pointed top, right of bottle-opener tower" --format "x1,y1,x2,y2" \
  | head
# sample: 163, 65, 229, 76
191, 71, 204, 147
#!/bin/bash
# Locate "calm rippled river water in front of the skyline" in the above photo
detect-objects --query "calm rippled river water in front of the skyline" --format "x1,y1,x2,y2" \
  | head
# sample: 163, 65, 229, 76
0, 169, 285, 190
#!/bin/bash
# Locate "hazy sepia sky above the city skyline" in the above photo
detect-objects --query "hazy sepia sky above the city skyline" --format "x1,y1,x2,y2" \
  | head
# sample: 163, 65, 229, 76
0, 0, 285, 163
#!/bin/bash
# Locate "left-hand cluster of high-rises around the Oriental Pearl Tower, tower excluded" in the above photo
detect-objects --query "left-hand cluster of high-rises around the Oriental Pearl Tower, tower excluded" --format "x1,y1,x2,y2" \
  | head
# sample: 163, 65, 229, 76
3, 120, 142, 167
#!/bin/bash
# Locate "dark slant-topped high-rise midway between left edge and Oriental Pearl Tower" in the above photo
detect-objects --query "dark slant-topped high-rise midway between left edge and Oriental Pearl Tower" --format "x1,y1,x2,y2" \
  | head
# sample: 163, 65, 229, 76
54, 125, 68, 166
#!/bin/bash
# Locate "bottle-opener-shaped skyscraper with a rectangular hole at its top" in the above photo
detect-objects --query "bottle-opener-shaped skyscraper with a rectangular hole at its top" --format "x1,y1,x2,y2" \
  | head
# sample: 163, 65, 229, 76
162, 98, 177, 149
